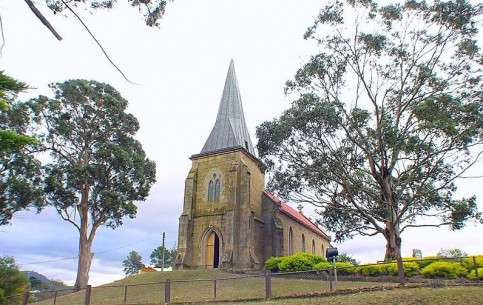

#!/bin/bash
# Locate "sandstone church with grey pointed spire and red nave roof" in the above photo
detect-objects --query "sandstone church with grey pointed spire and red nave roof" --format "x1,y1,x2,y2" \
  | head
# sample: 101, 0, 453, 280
175, 60, 330, 270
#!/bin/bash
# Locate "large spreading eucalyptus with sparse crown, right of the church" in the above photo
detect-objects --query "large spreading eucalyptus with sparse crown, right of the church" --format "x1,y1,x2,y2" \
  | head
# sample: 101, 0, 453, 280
257, 0, 483, 259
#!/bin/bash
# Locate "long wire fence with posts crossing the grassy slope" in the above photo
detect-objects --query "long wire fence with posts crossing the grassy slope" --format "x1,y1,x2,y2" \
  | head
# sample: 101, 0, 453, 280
12, 257, 481, 305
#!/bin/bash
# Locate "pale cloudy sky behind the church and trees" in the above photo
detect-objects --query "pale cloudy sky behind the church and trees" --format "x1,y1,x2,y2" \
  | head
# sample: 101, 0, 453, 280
0, 0, 483, 285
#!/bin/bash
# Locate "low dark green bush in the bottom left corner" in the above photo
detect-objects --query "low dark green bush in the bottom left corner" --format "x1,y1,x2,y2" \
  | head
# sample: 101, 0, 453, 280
0, 256, 29, 305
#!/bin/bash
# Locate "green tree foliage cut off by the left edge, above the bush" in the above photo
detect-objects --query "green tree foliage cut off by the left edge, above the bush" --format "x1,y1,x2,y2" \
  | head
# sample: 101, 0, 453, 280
0, 71, 42, 226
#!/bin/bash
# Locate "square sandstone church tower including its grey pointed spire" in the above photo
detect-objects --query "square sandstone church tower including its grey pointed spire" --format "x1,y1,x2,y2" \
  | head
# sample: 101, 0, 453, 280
175, 60, 265, 269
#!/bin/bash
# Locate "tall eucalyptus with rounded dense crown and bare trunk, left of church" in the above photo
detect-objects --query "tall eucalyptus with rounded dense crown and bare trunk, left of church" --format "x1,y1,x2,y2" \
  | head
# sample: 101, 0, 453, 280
29, 80, 156, 288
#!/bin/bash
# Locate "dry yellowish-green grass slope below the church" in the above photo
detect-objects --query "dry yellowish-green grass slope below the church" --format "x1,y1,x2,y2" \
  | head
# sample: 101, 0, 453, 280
29, 270, 483, 305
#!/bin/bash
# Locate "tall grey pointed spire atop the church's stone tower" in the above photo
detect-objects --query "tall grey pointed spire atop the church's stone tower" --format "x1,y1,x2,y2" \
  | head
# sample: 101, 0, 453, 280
200, 59, 255, 156
